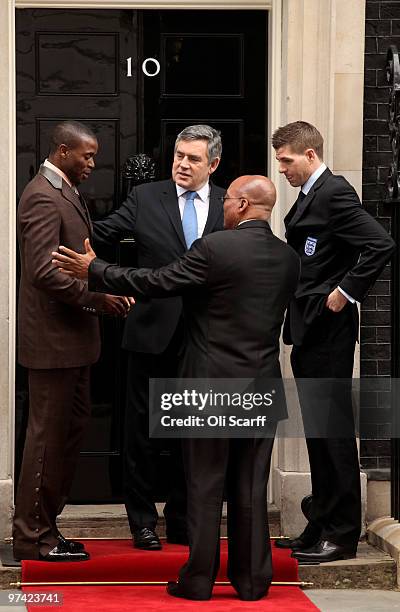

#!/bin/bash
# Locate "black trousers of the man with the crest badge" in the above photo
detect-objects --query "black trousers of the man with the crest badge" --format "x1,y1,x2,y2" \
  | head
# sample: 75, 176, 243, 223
291, 304, 361, 547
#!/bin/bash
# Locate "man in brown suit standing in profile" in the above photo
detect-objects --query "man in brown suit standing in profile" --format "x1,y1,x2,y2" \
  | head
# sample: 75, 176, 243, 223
13, 121, 129, 561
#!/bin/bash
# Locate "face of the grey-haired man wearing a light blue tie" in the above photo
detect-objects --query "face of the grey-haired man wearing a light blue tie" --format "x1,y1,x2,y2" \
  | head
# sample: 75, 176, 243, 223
172, 140, 219, 191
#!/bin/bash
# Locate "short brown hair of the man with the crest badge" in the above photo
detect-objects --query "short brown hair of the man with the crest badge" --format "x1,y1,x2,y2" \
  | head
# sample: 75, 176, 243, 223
272, 121, 324, 160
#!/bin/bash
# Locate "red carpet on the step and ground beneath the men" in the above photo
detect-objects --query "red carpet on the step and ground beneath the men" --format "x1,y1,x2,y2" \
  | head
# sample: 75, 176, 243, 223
22, 540, 317, 612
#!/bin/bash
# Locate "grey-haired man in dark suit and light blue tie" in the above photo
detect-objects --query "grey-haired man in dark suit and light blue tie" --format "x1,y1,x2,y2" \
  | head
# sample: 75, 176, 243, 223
89, 125, 225, 550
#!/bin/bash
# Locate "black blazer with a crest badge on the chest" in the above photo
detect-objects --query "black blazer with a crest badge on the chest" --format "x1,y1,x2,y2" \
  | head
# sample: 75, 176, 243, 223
284, 168, 395, 345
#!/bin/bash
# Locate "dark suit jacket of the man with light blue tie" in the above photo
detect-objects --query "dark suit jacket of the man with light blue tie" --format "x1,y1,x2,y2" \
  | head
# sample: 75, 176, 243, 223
94, 180, 225, 354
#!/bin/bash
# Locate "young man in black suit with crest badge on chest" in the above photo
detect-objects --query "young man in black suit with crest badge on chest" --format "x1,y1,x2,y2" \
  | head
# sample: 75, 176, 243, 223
272, 121, 394, 562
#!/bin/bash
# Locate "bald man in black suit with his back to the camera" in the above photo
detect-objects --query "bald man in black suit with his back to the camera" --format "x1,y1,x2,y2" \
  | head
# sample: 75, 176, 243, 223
54, 176, 299, 600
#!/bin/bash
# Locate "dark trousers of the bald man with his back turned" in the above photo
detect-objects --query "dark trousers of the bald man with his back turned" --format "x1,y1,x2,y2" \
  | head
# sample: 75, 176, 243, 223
179, 434, 274, 600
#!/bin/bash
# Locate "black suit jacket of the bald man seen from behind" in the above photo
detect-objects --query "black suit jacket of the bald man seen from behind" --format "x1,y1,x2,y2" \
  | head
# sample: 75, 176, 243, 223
89, 221, 299, 378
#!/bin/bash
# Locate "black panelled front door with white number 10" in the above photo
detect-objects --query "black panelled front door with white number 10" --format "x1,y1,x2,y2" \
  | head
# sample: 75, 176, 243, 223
16, 9, 267, 502
